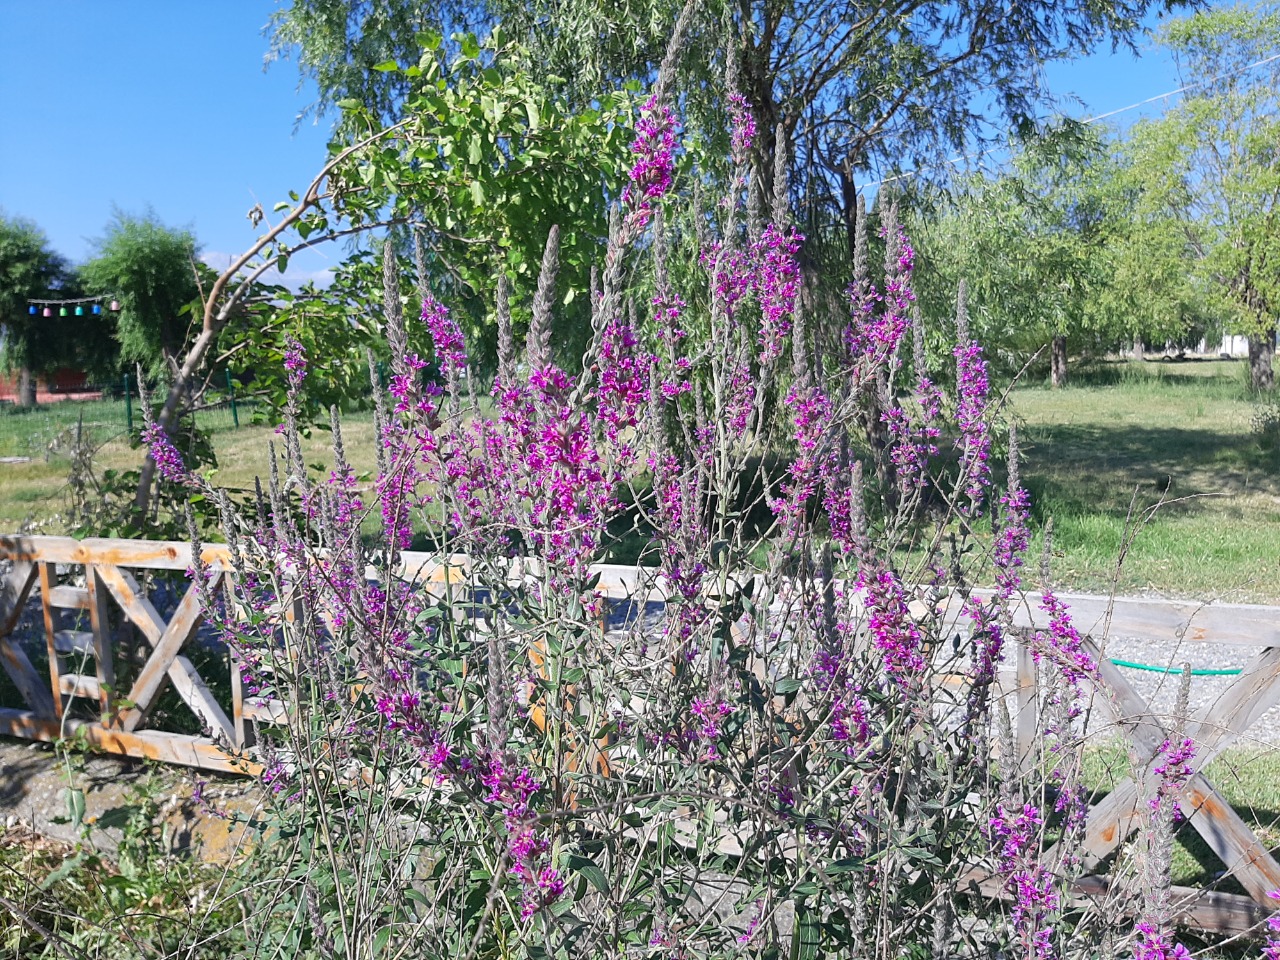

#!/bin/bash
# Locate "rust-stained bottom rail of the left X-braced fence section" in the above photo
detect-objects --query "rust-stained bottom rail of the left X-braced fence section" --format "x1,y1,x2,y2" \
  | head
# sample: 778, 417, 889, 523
0, 709, 262, 777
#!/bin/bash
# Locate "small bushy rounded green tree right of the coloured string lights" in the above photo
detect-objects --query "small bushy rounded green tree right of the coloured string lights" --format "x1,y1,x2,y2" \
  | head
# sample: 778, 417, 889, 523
81, 210, 209, 375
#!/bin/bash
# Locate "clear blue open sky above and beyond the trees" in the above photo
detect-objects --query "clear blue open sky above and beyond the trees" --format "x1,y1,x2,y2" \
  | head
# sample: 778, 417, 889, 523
0, 0, 1198, 280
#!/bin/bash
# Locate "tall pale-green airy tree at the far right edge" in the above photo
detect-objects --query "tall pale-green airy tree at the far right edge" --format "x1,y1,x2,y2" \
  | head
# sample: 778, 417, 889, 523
1134, 5, 1280, 390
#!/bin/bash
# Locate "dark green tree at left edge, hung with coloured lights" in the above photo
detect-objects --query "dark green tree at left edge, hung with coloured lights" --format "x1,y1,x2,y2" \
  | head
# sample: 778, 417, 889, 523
0, 214, 116, 406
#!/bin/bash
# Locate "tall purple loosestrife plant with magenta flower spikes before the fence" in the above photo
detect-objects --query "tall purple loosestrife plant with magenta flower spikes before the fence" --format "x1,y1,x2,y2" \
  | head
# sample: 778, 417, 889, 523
151, 45, 1239, 960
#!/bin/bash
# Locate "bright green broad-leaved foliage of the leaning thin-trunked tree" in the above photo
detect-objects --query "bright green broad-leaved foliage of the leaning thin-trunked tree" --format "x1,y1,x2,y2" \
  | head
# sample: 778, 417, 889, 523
240, 37, 634, 420
